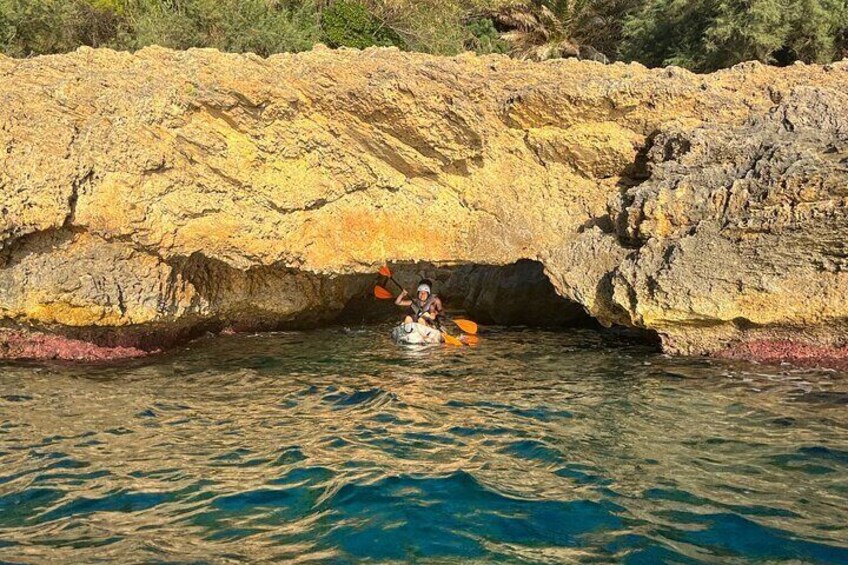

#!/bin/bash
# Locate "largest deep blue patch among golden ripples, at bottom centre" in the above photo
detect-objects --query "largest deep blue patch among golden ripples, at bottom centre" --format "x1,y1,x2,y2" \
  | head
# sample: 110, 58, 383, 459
326, 471, 622, 560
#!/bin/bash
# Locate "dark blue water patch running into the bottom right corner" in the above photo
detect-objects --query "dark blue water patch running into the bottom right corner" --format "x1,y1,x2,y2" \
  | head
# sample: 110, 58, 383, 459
662, 511, 848, 563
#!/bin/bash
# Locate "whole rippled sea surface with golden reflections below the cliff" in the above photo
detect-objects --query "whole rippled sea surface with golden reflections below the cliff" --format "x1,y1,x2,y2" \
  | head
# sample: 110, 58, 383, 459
0, 328, 848, 563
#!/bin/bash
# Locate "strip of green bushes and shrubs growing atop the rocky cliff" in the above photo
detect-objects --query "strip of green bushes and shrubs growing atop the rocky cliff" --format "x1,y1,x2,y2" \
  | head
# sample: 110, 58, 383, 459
0, 0, 848, 71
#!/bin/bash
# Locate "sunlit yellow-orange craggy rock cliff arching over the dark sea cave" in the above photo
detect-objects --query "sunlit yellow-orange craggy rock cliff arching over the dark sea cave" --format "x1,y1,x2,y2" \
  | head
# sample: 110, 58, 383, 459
0, 48, 848, 364
